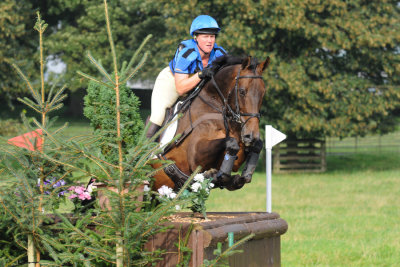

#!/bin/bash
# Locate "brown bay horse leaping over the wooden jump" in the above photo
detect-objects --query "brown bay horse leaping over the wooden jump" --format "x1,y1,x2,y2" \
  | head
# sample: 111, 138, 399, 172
153, 56, 270, 191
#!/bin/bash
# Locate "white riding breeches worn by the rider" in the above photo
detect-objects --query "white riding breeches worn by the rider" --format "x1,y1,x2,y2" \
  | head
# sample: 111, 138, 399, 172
150, 66, 179, 126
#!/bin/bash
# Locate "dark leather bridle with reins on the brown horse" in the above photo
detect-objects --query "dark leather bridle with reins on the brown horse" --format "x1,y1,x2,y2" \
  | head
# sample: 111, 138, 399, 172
199, 68, 263, 136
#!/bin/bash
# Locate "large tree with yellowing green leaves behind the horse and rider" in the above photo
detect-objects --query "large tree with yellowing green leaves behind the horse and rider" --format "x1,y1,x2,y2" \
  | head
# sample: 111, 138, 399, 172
129, 0, 400, 137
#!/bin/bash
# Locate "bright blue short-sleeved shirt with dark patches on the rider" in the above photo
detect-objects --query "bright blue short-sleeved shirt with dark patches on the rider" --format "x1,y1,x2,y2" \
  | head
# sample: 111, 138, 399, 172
169, 39, 226, 74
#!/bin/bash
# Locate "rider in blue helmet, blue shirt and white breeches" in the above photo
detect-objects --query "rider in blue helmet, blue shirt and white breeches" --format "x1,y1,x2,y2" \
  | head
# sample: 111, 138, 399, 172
146, 15, 226, 138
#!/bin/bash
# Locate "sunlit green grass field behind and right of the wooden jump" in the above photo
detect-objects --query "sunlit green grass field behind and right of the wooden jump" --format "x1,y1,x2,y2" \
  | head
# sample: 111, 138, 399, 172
207, 153, 400, 266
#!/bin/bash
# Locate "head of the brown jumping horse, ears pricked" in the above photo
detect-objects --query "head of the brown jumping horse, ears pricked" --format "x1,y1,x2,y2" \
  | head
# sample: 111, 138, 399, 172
228, 57, 270, 146
